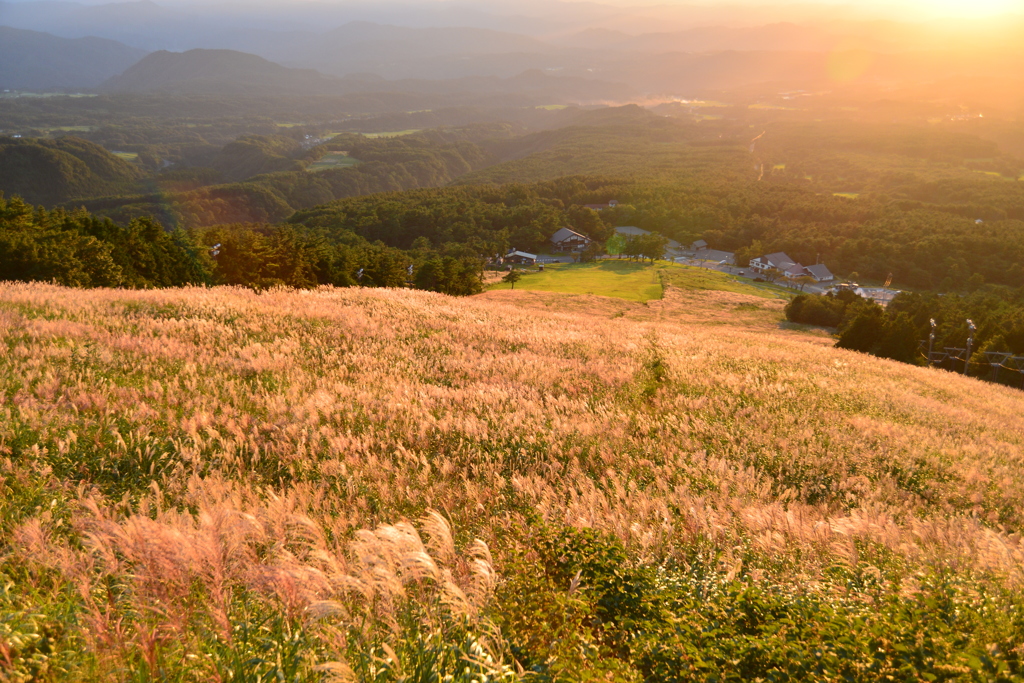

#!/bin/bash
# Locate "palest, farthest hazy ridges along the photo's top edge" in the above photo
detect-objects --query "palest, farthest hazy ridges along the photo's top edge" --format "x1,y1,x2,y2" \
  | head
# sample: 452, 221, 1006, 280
0, 0, 995, 49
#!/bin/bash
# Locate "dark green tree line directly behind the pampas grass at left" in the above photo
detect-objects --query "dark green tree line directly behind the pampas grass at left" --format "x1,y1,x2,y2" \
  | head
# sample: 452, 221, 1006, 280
0, 197, 483, 295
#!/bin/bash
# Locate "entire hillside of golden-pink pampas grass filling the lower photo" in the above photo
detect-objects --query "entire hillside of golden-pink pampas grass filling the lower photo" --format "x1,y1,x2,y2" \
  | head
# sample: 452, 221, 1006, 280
0, 284, 1024, 681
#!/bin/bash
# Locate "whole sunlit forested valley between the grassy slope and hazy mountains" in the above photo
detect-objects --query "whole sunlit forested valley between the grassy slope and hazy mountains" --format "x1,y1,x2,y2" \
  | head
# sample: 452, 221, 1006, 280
0, 98, 1024, 294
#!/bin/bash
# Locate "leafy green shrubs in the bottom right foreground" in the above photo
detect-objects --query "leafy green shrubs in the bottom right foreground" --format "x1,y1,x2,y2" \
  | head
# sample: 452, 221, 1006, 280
499, 529, 1024, 683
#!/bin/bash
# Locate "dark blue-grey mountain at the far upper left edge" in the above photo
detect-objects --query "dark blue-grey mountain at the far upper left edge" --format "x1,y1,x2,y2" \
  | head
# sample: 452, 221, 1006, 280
0, 27, 145, 90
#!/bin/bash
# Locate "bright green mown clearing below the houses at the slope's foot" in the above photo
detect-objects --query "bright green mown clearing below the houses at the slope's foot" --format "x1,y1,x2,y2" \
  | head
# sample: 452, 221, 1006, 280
489, 259, 781, 301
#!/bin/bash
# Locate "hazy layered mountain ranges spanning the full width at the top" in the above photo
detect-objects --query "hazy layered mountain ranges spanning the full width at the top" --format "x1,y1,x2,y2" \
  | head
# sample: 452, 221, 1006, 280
0, 0, 1024, 103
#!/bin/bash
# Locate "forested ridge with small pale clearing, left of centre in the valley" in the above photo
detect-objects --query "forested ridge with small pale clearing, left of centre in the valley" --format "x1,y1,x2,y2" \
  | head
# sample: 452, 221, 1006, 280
32, 134, 499, 228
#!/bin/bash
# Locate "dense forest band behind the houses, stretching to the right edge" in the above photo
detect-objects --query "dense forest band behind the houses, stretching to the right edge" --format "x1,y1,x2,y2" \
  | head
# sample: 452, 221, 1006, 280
290, 169, 1024, 292
